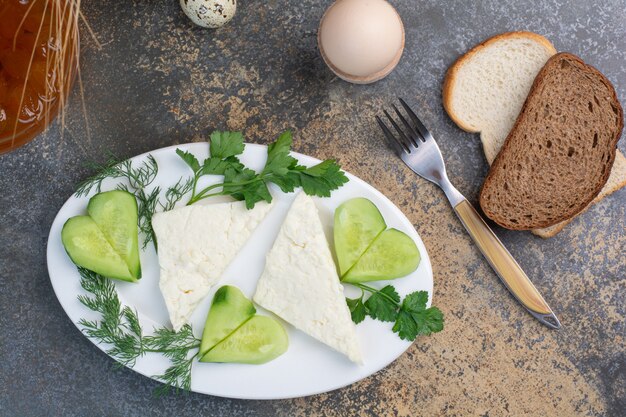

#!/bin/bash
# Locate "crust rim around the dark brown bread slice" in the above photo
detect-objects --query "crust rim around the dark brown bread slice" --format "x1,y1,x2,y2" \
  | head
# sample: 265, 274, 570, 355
479, 52, 624, 229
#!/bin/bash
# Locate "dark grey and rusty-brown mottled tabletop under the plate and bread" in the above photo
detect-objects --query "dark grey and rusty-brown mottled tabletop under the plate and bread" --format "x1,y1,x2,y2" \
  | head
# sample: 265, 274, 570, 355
0, 0, 626, 416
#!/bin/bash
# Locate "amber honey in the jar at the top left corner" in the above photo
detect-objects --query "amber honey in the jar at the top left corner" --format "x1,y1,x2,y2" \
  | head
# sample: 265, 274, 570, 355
0, 0, 78, 153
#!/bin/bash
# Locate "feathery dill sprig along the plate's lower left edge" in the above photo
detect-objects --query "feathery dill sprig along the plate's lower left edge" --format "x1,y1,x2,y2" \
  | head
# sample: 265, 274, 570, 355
78, 267, 200, 396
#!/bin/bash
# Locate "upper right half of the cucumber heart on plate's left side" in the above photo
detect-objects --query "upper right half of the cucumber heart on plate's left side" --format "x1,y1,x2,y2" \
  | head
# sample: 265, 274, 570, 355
87, 190, 141, 279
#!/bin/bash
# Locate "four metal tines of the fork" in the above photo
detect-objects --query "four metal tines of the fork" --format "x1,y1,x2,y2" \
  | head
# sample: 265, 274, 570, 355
376, 98, 432, 153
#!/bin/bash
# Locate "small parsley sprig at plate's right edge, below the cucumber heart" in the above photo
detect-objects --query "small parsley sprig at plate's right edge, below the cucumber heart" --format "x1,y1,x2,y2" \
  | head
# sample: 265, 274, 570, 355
346, 283, 443, 341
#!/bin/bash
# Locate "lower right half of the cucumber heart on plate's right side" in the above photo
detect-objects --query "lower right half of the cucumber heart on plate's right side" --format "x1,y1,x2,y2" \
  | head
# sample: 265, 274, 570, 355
342, 229, 421, 283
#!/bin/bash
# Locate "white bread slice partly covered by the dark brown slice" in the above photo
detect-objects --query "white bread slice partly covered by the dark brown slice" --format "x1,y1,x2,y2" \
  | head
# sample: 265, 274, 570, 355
443, 32, 626, 238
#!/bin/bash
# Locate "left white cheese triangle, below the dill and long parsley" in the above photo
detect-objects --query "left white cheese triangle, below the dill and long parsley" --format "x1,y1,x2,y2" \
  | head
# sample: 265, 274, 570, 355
152, 201, 272, 331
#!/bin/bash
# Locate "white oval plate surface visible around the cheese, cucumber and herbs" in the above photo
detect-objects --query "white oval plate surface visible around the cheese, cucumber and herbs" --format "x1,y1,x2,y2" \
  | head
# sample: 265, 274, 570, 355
48, 143, 433, 399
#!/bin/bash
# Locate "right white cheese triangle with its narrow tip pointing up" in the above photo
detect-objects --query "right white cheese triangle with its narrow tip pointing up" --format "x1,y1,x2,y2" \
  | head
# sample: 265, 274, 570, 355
254, 193, 363, 363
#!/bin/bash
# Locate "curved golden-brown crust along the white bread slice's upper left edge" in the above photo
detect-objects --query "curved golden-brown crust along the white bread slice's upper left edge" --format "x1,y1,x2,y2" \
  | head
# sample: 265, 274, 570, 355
442, 31, 557, 133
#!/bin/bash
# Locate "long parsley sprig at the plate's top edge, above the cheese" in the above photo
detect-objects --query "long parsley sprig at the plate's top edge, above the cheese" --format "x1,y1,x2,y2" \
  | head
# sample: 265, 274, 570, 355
176, 131, 348, 209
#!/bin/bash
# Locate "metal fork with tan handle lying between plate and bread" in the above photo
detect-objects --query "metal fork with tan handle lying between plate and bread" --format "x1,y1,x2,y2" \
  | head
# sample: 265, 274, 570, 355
376, 99, 561, 329
